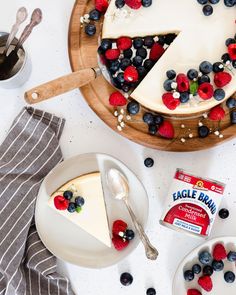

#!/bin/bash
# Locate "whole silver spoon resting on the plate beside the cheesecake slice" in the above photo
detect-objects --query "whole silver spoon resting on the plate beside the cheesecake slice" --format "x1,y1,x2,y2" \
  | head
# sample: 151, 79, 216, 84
106, 168, 159, 260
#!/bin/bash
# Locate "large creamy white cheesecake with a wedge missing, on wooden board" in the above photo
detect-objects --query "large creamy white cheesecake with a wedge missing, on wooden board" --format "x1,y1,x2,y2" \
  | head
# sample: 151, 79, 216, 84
102, 0, 236, 115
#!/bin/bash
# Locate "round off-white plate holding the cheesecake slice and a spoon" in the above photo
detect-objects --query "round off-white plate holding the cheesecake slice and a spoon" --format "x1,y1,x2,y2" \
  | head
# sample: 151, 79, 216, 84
35, 154, 148, 268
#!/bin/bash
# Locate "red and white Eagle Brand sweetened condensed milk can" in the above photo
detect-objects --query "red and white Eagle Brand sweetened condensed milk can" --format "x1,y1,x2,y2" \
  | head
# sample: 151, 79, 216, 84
160, 169, 225, 237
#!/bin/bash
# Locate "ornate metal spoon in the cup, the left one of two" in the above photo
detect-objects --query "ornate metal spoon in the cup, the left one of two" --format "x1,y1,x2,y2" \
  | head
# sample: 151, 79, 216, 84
0, 7, 28, 64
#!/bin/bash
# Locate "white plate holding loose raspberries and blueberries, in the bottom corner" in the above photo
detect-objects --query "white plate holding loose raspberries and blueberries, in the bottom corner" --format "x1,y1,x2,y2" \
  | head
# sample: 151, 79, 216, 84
172, 237, 236, 295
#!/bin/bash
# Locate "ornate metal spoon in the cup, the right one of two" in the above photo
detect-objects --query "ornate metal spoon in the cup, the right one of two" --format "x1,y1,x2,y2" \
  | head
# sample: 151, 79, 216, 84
0, 8, 42, 79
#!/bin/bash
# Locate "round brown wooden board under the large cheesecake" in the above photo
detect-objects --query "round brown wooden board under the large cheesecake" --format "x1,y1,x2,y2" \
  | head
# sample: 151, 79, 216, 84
68, 0, 236, 152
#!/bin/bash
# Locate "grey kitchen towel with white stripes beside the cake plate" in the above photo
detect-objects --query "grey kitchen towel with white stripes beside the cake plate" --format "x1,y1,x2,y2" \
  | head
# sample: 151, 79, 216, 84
0, 108, 74, 295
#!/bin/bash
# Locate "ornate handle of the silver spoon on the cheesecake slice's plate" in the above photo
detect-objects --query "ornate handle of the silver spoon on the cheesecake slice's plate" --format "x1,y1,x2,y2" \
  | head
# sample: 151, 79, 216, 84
124, 199, 159, 260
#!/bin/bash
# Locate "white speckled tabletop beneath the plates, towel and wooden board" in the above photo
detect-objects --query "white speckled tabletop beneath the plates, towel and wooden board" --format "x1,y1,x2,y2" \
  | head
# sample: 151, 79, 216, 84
0, 0, 236, 295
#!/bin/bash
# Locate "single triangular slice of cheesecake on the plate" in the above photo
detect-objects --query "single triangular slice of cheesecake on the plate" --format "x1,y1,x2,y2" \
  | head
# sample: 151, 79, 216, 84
48, 172, 111, 248
